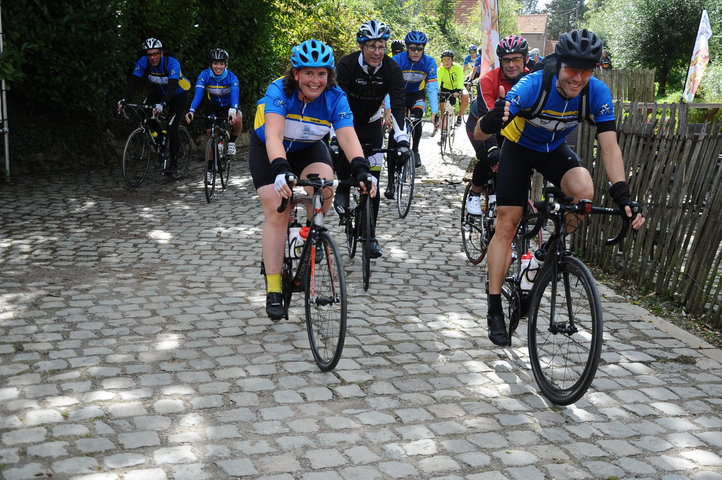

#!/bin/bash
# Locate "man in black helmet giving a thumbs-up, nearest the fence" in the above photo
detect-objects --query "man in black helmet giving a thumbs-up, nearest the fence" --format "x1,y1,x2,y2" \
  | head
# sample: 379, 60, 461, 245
474, 29, 644, 345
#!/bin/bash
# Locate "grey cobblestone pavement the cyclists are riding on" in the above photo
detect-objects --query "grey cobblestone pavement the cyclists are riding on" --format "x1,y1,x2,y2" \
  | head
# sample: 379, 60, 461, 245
0, 126, 722, 480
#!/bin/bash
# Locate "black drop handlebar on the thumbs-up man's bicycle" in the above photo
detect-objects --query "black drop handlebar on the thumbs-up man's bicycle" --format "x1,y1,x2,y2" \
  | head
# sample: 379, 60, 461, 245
529, 194, 642, 245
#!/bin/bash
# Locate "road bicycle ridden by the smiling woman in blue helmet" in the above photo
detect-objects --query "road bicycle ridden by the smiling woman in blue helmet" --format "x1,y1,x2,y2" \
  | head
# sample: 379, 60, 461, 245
261, 174, 347, 372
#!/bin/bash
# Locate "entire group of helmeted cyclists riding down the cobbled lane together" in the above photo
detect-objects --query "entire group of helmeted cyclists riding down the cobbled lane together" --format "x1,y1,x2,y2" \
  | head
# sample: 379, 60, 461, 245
118, 25, 644, 345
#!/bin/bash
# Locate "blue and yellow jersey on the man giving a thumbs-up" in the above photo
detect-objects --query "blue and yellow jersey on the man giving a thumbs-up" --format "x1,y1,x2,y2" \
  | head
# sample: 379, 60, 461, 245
501, 70, 614, 152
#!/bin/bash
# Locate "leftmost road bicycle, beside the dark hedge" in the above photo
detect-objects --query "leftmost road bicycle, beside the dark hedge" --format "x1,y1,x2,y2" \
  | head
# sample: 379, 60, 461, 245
123, 103, 191, 187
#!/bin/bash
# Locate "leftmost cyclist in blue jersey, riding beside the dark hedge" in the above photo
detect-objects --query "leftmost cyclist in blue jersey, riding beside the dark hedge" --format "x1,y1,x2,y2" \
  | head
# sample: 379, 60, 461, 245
118, 38, 191, 177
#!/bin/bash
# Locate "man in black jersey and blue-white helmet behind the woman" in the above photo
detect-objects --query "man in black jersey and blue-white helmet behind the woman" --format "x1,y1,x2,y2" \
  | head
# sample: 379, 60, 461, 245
334, 20, 411, 258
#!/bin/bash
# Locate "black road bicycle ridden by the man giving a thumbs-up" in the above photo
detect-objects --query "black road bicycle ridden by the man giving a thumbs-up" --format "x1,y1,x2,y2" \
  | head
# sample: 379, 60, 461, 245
502, 188, 641, 405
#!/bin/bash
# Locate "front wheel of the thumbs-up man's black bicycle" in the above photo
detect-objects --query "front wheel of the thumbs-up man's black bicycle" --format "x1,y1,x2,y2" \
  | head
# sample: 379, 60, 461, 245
527, 256, 603, 405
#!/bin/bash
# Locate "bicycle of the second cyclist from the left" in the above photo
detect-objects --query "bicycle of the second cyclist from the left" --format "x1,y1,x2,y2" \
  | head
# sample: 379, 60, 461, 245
196, 115, 233, 203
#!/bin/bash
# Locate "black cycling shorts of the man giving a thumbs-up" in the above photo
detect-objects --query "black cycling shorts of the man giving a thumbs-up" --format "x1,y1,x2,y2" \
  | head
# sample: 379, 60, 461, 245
496, 140, 584, 207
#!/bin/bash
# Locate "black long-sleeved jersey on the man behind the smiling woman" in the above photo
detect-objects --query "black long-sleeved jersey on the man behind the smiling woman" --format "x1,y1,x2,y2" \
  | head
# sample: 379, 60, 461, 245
336, 51, 406, 135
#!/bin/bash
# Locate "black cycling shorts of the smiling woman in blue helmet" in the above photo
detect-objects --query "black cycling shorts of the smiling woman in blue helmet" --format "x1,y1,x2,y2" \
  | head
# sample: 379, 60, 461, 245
248, 132, 333, 190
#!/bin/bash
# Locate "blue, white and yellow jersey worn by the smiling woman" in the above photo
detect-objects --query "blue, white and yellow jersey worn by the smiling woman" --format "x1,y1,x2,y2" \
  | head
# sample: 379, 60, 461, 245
253, 78, 353, 152
